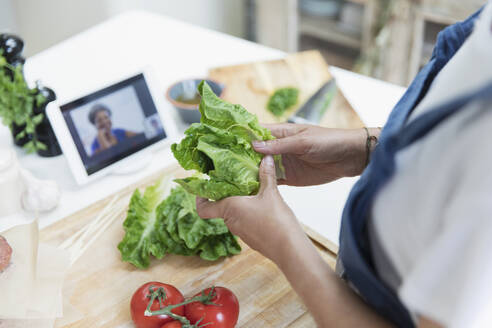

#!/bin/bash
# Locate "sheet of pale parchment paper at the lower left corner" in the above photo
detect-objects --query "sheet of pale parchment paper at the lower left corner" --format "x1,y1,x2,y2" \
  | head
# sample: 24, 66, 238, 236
0, 221, 70, 320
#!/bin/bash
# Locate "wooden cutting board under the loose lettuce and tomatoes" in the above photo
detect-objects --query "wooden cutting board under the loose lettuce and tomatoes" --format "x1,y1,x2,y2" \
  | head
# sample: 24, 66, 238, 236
40, 168, 334, 328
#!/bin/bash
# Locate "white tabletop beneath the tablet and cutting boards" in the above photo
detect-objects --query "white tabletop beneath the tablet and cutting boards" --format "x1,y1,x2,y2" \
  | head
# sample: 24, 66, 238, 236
0, 11, 404, 244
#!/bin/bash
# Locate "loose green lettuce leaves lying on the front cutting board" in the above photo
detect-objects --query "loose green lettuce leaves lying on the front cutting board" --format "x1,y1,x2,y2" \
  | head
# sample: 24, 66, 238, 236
118, 181, 241, 269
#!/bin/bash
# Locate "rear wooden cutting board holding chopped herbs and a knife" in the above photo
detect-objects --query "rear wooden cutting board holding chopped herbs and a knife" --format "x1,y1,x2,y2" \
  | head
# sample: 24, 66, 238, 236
209, 50, 364, 128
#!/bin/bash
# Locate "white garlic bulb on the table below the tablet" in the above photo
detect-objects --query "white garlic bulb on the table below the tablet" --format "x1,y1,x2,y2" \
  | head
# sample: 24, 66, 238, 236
21, 169, 60, 213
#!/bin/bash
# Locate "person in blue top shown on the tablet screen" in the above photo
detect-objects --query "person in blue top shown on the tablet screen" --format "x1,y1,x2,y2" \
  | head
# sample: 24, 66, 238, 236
89, 104, 137, 155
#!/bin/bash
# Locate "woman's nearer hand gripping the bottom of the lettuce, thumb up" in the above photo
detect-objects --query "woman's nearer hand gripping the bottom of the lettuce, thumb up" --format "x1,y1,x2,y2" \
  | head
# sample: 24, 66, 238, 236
197, 155, 305, 264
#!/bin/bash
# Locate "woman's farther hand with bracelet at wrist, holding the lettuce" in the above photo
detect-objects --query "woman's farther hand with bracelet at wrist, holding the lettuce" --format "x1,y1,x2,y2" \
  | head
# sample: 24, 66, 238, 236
253, 123, 379, 186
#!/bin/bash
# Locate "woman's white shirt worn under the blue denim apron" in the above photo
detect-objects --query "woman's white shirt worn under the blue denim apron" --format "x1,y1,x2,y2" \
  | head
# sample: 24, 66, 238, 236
370, 2, 492, 327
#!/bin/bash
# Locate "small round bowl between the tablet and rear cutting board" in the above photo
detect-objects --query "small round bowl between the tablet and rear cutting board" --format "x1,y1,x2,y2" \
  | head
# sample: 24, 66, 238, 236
166, 79, 224, 124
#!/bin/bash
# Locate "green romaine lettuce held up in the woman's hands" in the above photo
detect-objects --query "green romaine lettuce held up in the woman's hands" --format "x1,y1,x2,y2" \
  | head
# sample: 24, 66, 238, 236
171, 81, 285, 200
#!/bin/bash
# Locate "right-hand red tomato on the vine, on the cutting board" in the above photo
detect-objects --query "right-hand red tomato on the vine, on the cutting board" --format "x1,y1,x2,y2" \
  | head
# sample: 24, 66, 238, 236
185, 287, 239, 328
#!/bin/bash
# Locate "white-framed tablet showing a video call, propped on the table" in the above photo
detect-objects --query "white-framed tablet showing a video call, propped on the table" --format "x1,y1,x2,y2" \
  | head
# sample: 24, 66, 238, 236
47, 70, 177, 184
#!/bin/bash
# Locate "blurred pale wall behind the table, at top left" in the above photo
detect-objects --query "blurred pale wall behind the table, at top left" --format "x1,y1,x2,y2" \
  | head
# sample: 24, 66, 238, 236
0, 0, 245, 57
